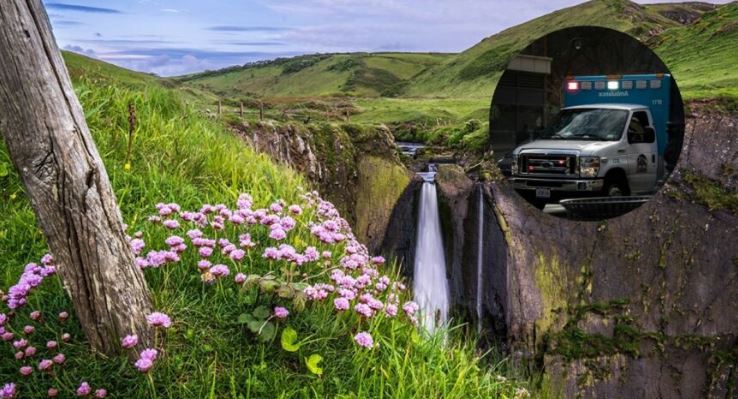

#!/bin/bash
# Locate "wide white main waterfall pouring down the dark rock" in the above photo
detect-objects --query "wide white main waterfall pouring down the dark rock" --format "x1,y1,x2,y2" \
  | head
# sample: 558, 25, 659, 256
413, 167, 448, 333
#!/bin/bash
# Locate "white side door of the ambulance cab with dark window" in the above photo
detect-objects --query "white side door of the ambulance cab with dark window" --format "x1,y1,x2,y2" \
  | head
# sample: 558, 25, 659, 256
627, 111, 658, 194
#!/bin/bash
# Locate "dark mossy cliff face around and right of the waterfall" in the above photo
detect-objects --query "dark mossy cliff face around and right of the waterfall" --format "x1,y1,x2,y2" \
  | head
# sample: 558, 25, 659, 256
383, 106, 738, 398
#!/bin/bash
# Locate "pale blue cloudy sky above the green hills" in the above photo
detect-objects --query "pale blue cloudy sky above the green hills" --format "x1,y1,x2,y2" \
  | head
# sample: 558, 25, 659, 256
44, 0, 727, 76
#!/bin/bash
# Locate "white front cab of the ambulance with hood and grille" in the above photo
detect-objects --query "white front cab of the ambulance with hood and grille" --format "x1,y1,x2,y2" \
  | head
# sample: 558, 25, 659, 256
511, 104, 663, 202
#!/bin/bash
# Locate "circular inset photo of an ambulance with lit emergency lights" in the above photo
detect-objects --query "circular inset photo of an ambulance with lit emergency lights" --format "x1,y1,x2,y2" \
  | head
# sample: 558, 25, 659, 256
489, 26, 684, 220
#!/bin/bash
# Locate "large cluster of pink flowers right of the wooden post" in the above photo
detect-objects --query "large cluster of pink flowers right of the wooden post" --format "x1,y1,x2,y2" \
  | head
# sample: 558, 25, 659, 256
134, 192, 417, 350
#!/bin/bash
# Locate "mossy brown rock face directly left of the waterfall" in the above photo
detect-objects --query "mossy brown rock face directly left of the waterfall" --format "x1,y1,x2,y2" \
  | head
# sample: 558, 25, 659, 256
230, 122, 410, 251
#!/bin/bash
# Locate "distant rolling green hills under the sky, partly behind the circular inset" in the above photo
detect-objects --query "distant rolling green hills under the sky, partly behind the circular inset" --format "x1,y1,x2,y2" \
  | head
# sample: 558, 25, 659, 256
180, 0, 738, 104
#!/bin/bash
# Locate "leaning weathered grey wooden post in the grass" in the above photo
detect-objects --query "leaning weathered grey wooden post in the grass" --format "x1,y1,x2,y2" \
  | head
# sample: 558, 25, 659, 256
0, 0, 152, 353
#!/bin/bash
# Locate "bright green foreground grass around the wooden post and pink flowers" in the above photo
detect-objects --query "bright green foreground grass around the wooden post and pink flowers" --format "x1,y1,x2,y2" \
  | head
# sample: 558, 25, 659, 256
0, 57, 523, 398
